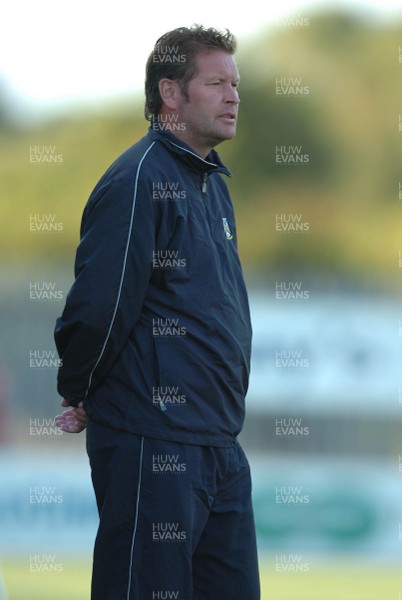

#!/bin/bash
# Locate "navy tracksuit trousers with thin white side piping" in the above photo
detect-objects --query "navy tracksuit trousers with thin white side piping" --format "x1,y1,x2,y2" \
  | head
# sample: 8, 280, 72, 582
87, 421, 260, 600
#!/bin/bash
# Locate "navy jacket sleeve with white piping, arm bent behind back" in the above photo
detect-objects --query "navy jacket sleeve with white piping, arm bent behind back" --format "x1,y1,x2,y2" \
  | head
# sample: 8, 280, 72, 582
55, 171, 155, 406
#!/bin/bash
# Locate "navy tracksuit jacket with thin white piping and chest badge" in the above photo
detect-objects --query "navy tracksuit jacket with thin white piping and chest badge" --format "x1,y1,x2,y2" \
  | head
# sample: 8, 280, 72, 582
55, 123, 251, 446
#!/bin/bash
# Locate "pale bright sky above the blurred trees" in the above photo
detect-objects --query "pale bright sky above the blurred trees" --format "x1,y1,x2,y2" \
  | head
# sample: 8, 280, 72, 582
0, 0, 402, 119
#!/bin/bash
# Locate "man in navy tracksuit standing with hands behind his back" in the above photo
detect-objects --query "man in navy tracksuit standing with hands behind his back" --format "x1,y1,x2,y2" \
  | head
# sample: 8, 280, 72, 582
55, 26, 260, 600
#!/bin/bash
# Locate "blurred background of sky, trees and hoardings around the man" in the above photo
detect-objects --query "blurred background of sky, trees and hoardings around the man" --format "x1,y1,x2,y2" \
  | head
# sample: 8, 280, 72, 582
0, 0, 402, 600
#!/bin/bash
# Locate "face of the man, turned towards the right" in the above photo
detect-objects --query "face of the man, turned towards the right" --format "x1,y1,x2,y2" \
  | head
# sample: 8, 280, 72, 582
177, 50, 240, 157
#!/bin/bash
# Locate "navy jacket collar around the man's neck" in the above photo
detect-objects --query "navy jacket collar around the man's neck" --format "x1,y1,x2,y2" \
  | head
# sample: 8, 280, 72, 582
148, 120, 232, 177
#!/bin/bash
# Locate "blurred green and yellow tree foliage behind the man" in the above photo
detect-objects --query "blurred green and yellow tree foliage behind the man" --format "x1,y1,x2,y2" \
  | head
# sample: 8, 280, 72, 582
0, 13, 402, 284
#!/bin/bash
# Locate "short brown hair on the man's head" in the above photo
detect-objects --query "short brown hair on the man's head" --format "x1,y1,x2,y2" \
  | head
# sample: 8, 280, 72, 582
144, 25, 237, 121
